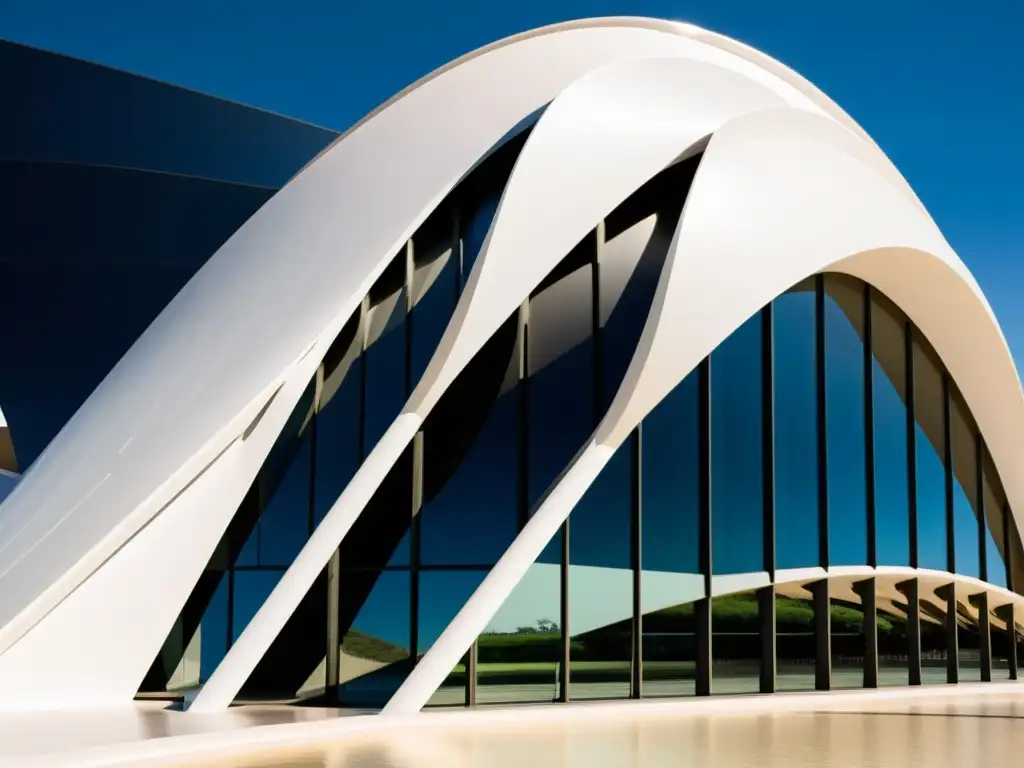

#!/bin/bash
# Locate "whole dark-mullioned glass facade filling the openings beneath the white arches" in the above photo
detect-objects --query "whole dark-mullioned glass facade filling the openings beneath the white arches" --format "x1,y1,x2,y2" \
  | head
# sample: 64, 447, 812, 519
146, 141, 1024, 708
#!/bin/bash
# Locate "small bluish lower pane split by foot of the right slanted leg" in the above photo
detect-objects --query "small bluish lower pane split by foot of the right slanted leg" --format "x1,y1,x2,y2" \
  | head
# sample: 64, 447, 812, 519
416, 570, 487, 707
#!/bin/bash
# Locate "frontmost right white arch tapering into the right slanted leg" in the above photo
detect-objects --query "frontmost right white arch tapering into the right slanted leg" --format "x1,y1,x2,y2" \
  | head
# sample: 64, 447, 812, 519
386, 110, 1024, 713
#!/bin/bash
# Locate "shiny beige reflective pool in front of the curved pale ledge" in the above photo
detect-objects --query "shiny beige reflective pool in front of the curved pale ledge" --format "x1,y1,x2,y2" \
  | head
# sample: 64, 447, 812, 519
174, 692, 1024, 768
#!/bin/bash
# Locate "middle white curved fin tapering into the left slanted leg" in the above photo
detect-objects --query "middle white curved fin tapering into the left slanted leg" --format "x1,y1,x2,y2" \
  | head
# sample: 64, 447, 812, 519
190, 58, 784, 712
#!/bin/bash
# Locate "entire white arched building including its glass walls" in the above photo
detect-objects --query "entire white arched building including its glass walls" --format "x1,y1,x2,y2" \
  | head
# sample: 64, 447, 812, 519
0, 18, 1024, 713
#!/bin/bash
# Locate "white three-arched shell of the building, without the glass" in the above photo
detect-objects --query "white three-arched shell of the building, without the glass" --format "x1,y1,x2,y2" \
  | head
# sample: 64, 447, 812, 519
0, 18, 1024, 709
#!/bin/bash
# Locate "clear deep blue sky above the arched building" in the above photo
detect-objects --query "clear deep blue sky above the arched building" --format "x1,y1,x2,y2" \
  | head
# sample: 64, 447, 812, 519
6, 0, 1024, 364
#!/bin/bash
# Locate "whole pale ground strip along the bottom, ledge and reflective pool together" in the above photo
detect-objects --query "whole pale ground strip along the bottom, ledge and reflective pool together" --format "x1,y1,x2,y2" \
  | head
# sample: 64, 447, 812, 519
0, 682, 1024, 768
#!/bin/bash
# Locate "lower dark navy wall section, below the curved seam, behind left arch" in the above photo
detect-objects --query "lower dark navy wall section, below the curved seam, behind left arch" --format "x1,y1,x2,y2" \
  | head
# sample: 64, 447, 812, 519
0, 160, 271, 462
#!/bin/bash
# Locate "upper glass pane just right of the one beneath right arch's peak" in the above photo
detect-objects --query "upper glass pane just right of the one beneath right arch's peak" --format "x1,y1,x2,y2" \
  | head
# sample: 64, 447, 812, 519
871, 290, 910, 565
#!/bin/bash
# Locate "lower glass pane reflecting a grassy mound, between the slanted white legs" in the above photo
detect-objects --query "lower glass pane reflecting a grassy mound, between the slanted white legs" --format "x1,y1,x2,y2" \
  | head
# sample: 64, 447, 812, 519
339, 571, 412, 706
